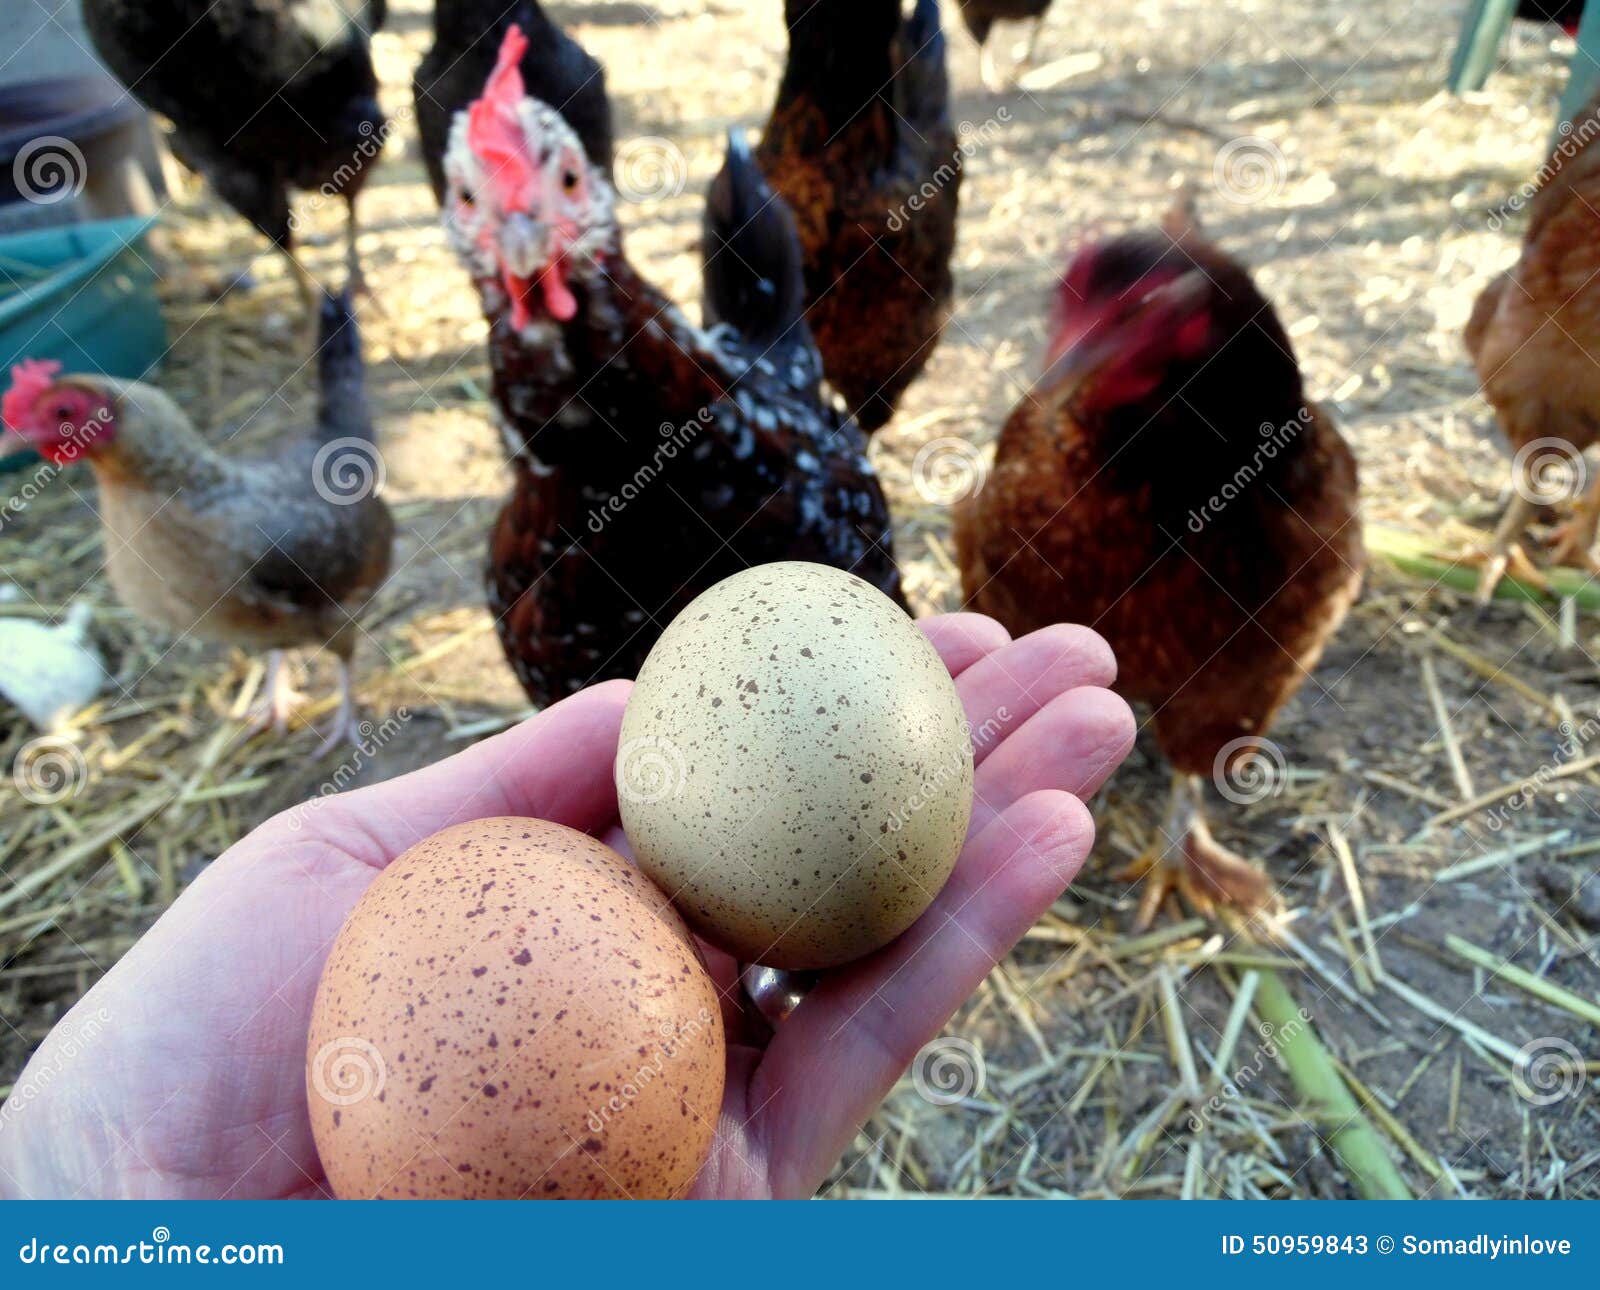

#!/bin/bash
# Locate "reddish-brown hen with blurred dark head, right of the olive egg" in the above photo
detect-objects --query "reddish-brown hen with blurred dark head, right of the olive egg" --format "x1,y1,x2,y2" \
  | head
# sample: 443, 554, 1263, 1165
955, 201, 1365, 925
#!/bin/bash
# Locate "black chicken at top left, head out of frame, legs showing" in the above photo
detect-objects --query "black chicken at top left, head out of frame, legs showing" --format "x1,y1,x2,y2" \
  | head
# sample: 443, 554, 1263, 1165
83, 0, 386, 317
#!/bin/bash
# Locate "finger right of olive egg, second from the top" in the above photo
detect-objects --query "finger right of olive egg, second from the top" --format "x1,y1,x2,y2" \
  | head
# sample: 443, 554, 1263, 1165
955, 623, 1117, 763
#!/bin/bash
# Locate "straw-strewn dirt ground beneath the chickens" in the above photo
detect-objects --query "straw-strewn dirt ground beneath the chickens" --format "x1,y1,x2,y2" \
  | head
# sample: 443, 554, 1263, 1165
0, 0, 1600, 1197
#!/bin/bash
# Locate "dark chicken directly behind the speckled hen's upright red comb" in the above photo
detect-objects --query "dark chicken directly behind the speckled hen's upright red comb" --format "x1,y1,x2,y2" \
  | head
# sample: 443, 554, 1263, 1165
411, 0, 614, 202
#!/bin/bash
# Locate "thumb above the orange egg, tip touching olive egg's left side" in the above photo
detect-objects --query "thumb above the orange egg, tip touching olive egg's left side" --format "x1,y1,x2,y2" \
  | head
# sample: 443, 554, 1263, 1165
294, 680, 632, 867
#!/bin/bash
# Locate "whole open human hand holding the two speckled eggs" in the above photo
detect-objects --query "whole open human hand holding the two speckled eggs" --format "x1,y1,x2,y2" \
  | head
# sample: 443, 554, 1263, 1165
0, 615, 1134, 1197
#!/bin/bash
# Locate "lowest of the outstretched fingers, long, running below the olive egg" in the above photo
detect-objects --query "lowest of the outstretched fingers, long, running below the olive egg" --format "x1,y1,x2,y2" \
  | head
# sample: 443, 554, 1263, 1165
750, 792, 1094, 1196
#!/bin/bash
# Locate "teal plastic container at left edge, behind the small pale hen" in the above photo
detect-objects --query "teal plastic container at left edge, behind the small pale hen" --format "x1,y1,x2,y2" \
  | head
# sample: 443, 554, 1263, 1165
0, 216, 166, 472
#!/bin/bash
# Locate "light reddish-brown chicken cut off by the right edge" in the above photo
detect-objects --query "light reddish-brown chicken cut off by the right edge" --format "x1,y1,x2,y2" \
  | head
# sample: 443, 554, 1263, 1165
1466, 86, 1600, 603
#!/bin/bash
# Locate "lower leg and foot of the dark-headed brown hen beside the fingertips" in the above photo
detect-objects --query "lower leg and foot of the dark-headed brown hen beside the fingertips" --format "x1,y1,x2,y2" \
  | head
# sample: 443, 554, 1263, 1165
1117, 770, 1272, 931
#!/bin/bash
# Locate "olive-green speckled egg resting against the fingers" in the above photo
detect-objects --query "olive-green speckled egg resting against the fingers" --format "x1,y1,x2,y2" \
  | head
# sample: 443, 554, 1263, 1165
616, 562, 973, 968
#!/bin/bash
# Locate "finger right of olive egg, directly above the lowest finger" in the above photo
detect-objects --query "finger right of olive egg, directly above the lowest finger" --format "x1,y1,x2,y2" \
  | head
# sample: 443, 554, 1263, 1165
968, 687, 1138, 834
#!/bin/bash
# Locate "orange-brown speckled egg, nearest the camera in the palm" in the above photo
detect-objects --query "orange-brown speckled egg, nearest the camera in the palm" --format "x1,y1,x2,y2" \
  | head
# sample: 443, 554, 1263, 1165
306, 818, 726, 1199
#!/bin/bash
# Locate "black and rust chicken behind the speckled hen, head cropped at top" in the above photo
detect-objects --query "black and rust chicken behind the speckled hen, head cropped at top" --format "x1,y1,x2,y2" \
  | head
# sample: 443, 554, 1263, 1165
757, 0, 963, 432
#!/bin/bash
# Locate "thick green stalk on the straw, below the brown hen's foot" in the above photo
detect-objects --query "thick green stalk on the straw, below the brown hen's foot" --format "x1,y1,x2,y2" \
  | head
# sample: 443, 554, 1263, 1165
1256, 972, 1413, 1200
